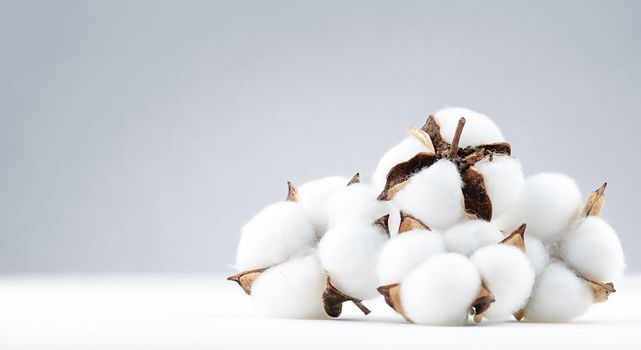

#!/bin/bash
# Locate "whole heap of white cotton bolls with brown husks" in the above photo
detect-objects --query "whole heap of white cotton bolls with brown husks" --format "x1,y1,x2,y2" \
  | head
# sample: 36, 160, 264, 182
229, 108, 624, 325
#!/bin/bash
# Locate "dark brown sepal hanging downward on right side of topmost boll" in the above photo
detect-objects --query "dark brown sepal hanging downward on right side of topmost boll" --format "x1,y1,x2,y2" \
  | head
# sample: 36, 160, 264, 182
461, 166, 492, 221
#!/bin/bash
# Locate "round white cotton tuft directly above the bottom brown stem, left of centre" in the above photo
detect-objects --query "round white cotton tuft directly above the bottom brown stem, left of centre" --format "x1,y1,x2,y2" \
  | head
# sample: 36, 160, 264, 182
318, 223, 388, 300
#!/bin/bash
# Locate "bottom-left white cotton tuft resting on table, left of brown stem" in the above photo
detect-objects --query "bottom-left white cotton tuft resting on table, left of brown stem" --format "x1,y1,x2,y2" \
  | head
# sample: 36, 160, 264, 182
251, 255, 327, 319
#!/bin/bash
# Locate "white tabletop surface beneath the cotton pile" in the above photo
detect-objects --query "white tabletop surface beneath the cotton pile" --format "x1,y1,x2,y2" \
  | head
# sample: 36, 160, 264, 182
0, 275, 641, 350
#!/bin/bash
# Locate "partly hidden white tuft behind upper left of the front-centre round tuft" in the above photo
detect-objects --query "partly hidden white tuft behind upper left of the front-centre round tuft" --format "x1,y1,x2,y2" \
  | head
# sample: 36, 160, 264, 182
378, 229, 446, 285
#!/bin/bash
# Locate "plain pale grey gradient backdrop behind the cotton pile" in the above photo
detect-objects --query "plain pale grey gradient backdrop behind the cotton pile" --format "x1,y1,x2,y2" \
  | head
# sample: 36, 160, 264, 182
0, 0, 641, 273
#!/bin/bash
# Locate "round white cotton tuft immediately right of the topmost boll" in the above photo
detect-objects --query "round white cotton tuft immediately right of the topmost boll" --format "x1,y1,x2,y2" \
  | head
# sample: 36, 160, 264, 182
516, 173, 581, 242
